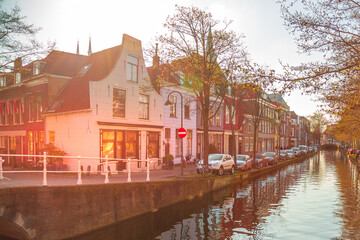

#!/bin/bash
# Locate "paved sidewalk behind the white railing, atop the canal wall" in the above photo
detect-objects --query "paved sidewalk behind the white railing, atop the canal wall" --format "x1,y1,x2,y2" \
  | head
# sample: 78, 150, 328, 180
0, 166, 196, 188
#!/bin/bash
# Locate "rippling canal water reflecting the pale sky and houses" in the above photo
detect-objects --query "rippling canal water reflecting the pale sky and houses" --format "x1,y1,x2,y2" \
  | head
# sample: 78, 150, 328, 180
71, 151, 360, 240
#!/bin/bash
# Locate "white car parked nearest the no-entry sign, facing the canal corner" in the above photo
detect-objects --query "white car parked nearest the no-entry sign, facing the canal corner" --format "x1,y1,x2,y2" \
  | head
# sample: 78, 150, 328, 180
196, 154, 235, 176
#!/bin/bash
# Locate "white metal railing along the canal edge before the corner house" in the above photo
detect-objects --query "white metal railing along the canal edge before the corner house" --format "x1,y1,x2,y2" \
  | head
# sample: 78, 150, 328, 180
0, 152, 158, 186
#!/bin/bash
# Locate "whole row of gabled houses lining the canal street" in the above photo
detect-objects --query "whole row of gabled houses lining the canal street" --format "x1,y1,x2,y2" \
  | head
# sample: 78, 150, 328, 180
0, 34, 309, 170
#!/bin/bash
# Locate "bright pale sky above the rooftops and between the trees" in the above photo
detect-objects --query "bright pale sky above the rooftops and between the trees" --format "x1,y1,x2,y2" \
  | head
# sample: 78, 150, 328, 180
3, 0, 320, 116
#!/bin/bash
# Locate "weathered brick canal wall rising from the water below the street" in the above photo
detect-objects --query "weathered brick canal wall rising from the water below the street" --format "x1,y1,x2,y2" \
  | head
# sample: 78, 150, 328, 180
0, 153, 316, 239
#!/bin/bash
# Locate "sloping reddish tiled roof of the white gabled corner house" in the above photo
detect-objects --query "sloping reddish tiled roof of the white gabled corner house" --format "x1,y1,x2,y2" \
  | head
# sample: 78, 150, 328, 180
46, 45, 122, 113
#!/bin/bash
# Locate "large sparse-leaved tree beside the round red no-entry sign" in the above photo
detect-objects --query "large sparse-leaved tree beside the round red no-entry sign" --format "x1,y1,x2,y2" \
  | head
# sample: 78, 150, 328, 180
151, 6, 247, 168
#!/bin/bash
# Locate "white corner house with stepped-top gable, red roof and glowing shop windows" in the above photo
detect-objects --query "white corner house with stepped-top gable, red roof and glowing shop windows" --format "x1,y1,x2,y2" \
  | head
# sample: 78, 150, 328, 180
45, 34, 164, 171
